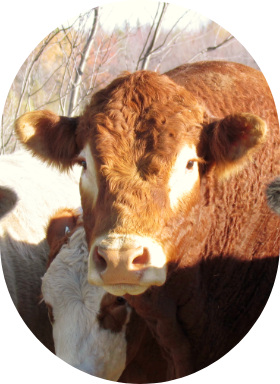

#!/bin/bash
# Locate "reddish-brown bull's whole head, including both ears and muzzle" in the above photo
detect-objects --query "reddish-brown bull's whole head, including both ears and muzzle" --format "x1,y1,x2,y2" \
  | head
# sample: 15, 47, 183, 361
17, 71, 266, 296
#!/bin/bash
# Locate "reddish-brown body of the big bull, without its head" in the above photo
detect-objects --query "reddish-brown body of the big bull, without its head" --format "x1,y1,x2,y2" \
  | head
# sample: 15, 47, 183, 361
126, 62, 280, 380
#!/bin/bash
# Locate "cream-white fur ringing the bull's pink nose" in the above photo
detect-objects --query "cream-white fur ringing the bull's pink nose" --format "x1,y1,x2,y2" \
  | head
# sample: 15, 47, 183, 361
88, 234, 167, 296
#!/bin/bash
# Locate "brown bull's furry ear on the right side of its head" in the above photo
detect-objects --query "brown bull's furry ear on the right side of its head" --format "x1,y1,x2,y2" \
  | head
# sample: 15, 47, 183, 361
198, 113, 267, 178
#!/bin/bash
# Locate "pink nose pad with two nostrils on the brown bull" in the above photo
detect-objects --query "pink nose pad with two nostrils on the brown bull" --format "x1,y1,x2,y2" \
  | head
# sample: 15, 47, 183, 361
92, 247, 151, 284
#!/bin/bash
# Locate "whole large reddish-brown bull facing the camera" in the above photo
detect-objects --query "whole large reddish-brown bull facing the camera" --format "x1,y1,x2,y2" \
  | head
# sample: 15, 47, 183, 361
16, 61, 280, 380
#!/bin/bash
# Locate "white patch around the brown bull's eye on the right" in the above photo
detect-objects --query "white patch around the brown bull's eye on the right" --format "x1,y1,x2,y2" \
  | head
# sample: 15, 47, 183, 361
168, 145, 199, 209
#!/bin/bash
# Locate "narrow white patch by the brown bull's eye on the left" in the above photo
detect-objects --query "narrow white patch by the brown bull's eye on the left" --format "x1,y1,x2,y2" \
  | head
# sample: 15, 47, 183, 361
79, 144, 98, 206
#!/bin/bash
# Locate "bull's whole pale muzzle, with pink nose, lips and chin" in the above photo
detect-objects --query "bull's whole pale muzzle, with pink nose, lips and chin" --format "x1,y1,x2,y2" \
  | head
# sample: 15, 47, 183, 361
88, 235, 166, 295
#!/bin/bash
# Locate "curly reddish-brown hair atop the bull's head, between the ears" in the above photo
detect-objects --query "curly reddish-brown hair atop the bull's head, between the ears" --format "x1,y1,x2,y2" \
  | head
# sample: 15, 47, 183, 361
78, 71, 208, 149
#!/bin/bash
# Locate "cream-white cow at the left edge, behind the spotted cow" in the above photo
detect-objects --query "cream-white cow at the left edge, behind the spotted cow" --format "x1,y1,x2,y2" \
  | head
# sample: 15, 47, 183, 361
0, 152, 80, 353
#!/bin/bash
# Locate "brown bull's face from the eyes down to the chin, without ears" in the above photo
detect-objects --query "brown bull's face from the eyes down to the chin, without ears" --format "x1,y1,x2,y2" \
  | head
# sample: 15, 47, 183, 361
78, 143, 200, 295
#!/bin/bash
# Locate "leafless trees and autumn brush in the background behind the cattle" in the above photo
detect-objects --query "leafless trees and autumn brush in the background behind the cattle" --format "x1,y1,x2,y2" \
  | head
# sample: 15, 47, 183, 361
0, 6, 258, 154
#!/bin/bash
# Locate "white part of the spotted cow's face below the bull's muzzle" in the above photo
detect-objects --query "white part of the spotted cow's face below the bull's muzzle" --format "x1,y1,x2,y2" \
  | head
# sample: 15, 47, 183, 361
42, 227, 131, 381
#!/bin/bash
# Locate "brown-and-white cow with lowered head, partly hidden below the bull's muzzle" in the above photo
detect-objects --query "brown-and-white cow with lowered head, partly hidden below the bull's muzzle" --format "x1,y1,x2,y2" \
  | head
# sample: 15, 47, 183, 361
42, 209, 166, 384
